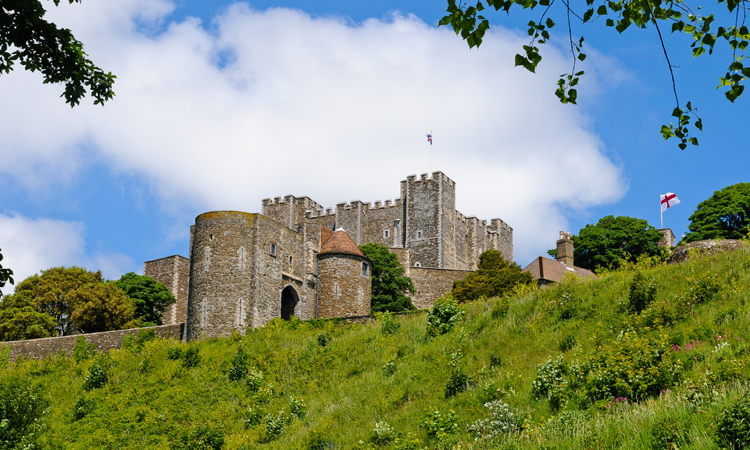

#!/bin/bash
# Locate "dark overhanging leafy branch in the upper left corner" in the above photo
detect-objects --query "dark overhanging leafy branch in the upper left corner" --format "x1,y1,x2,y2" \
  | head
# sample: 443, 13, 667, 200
0, 0, 116, 107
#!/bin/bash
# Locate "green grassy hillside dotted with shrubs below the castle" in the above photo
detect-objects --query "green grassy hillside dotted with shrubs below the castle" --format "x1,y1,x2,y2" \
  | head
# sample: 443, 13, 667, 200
2, 249, 750, 449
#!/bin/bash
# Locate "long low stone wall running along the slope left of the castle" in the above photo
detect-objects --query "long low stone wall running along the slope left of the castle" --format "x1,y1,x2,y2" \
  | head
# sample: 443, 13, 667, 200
0, 323, 185, 361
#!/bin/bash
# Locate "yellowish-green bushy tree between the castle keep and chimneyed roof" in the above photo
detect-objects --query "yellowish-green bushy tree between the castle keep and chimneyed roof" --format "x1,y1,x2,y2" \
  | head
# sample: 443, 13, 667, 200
451, 250, 534, 302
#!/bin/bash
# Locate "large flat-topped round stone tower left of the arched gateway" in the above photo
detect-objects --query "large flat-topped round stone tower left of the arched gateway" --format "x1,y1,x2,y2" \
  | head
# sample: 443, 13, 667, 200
187, 211, 256, 340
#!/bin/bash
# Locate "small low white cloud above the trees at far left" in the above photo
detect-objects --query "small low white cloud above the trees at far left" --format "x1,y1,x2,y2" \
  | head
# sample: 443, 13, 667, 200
0, 213, 134, 294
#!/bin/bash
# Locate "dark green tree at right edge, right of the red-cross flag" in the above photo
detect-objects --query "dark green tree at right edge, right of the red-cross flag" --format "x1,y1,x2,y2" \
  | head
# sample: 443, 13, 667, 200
685, 183, 750, 242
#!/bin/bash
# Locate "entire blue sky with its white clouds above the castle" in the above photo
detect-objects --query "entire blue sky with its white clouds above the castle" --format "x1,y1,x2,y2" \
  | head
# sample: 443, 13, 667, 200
0, 0, 748, 288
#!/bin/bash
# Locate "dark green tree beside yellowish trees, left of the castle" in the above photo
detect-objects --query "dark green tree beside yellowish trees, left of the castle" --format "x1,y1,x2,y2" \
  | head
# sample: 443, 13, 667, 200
115, 272, 177, 325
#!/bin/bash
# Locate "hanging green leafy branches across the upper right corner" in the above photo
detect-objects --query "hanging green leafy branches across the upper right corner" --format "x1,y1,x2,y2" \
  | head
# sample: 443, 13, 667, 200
440, 0, 750, 150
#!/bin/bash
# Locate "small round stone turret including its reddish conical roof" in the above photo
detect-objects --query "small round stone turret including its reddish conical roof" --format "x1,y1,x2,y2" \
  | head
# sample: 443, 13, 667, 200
316, 228, 372, 318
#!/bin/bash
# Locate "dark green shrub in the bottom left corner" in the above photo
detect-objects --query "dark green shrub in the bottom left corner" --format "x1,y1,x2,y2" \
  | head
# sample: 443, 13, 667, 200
0, 377, 49, 449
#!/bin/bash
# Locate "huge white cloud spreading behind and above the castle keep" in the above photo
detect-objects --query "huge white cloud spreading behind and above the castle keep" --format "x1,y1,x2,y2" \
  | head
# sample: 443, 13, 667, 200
0, 0, 626, 263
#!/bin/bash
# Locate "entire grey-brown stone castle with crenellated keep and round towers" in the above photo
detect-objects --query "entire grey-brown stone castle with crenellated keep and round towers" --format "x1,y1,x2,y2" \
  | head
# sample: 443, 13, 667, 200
144, 172, 513, 340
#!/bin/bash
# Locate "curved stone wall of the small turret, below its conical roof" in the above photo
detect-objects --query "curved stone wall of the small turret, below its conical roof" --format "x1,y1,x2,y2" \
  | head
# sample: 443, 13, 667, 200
317, 253, 372, 318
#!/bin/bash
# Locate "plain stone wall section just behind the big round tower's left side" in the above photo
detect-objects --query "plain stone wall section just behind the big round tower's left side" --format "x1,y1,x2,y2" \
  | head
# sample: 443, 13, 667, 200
143, 255, 190, 325
